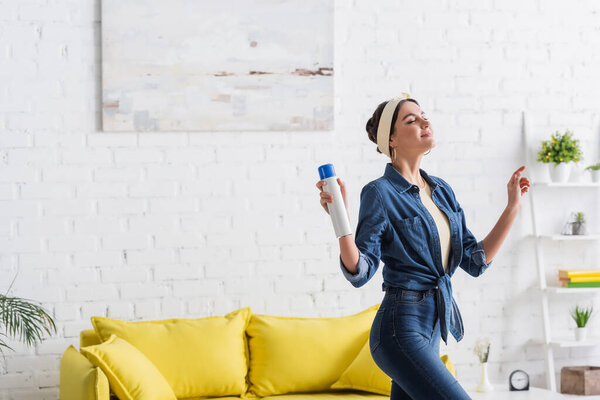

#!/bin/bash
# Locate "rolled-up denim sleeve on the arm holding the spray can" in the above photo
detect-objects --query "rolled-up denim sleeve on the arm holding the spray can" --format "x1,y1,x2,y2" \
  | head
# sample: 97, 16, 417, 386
340, 184, 388, 287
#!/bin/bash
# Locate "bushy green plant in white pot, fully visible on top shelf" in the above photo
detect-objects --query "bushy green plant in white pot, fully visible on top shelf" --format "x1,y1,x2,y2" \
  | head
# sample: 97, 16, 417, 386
537, 130, 583, 182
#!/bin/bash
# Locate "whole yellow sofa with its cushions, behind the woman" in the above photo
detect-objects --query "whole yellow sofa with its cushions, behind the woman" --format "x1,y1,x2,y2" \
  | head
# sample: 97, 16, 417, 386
60, 304, 456, 400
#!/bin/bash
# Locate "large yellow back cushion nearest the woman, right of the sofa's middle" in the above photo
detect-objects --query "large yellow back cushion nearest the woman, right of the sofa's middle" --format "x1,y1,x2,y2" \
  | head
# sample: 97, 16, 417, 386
246, 304, 379, 397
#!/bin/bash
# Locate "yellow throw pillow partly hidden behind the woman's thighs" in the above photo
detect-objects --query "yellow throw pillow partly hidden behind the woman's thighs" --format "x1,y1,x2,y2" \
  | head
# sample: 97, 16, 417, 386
331, 340, 456, 396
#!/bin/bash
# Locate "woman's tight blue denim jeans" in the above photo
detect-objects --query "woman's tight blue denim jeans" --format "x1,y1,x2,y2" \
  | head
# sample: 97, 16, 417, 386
369, 287, 471, 400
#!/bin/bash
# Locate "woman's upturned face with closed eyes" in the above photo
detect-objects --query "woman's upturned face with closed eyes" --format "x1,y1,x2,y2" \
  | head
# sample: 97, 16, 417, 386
390, 101, 435, 157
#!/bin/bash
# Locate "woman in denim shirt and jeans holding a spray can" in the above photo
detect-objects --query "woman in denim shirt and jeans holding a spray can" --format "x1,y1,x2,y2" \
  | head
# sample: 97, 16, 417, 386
317, 95, 529, 400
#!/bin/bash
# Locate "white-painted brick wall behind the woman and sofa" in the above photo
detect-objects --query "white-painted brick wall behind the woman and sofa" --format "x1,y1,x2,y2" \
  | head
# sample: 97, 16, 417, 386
0, 0, 600, 400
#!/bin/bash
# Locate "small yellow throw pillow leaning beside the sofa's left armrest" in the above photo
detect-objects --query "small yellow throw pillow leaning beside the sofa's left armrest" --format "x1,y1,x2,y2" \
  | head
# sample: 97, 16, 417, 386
81, 335, 177, 400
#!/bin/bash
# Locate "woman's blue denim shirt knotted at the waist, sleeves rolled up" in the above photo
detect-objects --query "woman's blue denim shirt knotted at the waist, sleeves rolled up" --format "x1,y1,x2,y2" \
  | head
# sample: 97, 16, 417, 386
340, 163, 492, 345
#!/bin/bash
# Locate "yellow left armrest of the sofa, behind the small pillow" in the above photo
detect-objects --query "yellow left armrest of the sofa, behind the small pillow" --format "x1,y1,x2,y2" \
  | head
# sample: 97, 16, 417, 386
60, 346, 110, 400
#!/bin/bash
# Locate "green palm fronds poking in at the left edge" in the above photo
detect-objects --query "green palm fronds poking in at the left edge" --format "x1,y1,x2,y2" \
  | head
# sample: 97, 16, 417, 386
0, 277, 56, 356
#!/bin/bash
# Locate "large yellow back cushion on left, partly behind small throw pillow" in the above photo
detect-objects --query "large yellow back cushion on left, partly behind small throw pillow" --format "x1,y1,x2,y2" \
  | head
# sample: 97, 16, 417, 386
92, 307, 251, 399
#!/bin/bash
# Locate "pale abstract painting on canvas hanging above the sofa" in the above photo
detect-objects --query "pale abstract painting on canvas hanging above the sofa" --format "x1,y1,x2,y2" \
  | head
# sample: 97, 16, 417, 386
101, 0, 333, 131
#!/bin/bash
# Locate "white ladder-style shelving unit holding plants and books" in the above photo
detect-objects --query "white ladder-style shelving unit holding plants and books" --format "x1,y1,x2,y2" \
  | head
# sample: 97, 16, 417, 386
523, 113, 600, 392
